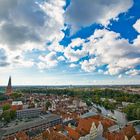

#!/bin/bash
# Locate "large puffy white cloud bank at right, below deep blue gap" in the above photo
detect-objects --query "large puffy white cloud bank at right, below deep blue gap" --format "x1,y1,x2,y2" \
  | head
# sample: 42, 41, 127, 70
64, 29, 140, 75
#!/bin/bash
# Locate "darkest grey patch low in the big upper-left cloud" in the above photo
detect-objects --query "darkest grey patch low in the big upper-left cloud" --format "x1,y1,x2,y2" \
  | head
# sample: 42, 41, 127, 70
0, 23, 40, 46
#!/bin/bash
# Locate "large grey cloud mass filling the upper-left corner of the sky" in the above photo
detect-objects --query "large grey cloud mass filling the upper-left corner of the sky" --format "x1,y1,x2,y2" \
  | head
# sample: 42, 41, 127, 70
0, 0, 47, 49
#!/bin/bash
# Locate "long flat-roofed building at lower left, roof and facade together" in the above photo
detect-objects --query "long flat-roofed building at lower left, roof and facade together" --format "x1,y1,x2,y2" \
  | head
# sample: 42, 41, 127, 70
0, 114, 62, 140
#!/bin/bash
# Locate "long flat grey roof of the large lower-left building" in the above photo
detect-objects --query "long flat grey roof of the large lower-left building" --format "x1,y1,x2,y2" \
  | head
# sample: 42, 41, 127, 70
0, 114, 60, 137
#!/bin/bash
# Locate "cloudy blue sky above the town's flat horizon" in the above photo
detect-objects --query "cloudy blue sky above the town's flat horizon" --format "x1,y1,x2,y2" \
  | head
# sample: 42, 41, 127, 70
0, 0, 140, 85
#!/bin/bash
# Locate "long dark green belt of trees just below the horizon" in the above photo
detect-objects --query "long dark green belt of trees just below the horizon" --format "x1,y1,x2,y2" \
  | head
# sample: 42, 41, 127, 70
18, 87, 140, 103
